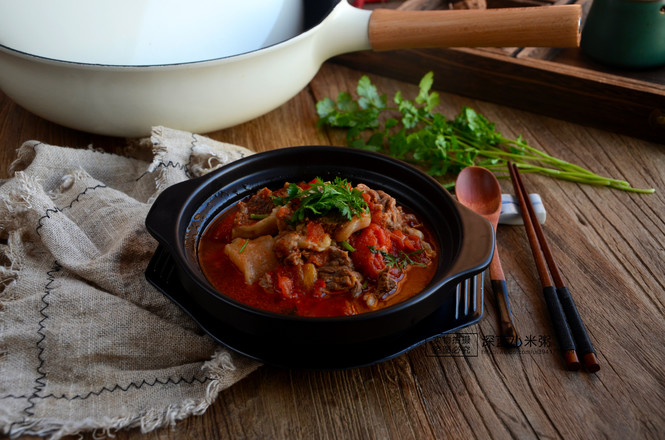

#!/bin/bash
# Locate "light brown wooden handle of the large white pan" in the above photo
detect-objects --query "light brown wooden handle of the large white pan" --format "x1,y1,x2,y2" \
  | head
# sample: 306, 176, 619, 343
369, 5, 582, 50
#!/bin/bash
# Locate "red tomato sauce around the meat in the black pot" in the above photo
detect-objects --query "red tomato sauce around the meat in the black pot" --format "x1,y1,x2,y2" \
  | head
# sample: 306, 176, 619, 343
198, 183, 439, 317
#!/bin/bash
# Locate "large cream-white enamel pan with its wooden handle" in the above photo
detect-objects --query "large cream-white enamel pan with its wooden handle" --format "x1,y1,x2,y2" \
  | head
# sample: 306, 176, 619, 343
0, 0, 581, 137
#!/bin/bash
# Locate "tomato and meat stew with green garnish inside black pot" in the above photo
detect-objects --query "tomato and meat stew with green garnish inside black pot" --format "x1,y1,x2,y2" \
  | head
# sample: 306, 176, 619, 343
199, 178, 438, 316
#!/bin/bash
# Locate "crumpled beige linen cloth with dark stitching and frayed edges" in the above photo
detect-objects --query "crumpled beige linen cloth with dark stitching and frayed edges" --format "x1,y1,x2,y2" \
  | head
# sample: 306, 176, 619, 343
0, 127, 258, 438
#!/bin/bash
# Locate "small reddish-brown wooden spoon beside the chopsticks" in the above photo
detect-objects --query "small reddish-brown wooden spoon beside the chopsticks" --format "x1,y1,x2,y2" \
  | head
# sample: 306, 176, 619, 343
455, 167, 522, 347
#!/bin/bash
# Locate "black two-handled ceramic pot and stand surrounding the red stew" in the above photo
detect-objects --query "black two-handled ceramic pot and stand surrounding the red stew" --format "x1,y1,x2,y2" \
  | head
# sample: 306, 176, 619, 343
146, 147, 494, 368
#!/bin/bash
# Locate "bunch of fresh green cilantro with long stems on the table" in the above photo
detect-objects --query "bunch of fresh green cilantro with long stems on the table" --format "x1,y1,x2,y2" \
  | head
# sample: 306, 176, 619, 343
316, 72, 654, 193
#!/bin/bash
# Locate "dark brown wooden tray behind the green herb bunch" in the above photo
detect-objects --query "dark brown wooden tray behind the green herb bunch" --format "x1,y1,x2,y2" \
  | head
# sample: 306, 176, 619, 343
332, 0, 665, 142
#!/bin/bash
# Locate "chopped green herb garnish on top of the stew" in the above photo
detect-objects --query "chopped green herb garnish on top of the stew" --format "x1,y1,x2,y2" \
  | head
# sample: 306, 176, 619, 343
273, 177, 369, 224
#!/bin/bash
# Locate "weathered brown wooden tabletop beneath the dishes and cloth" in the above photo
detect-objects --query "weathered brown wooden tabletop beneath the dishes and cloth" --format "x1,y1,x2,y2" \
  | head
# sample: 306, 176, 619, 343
0, 63, 665, 440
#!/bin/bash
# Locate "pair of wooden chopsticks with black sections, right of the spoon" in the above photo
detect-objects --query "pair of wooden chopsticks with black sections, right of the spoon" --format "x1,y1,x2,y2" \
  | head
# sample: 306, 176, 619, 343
508, 162, 600, 373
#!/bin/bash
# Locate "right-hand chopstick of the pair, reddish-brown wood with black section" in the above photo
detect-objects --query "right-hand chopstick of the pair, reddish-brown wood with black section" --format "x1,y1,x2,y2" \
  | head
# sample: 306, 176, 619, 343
511, 164, 600, 373
